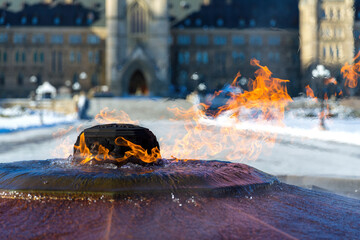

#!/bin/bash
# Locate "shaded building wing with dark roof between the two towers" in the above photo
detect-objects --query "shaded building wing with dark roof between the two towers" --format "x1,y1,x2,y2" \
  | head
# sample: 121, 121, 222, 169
171, 0, 300, 94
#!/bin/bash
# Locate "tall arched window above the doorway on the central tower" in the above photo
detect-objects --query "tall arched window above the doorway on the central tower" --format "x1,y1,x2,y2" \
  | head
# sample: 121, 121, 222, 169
129, 2, 148, 36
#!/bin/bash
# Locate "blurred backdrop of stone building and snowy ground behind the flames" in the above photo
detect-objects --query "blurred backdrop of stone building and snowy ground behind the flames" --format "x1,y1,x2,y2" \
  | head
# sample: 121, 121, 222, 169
0, 0, 360, 197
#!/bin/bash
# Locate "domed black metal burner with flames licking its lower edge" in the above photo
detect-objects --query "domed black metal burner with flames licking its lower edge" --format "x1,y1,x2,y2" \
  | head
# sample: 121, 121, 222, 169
74, 123, 160, 165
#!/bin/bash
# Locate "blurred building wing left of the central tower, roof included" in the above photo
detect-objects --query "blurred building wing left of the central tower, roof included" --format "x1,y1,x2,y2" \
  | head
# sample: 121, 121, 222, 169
0, 0, 106, 97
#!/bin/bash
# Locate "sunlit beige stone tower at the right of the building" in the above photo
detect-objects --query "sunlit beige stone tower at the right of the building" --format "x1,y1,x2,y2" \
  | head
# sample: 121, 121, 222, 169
299, 0, 354, 87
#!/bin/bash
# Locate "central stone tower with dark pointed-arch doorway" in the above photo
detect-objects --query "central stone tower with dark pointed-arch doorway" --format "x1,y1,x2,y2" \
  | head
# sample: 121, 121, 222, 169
106, 0, 170, 96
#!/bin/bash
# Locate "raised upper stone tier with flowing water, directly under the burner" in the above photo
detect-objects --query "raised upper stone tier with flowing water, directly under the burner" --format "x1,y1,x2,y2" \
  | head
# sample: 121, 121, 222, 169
0, 159, 278, 198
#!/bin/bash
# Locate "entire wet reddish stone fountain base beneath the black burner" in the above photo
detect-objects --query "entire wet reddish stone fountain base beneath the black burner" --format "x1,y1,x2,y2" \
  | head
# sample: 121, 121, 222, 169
0, 159, 360, 239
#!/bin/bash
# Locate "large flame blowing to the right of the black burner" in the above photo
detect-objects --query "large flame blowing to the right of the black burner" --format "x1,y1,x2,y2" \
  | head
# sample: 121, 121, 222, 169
162, 59, 291, 160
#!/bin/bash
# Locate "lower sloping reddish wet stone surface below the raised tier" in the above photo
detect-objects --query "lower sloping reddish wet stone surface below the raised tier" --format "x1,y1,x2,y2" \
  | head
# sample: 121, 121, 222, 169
0, 184, 360, 239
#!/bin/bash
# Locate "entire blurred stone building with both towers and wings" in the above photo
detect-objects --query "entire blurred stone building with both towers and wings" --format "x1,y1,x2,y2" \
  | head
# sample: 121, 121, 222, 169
0, 0, 360, 97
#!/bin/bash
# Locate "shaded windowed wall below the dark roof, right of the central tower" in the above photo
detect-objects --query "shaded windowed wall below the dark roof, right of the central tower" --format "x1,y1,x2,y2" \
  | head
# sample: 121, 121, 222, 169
171, 29, 300, 95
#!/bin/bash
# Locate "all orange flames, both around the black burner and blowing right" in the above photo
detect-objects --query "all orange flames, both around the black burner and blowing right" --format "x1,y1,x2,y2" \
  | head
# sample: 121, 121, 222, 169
57, 59, 291, 164
